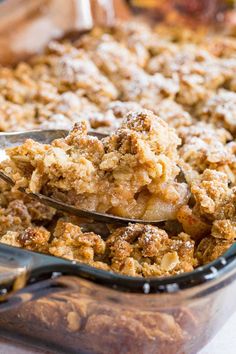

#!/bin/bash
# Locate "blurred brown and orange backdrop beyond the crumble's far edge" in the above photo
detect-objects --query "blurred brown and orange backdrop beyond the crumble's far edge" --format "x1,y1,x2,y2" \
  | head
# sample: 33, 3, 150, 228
0, 0, 236, 65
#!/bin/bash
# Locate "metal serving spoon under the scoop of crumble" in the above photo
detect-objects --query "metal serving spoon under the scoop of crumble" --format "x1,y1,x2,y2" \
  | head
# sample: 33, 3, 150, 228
0, 130, 166, 225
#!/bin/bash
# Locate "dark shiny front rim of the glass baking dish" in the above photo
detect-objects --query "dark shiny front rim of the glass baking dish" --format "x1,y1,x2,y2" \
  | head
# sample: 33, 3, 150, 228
0, 243, 236, 295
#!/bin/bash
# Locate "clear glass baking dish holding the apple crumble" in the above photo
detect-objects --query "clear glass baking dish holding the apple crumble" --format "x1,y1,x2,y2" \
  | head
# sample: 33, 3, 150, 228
0, 0, 236, 354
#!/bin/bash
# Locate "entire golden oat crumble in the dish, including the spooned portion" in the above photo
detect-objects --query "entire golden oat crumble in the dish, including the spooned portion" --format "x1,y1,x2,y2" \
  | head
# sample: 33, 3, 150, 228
0, 22, 236, 277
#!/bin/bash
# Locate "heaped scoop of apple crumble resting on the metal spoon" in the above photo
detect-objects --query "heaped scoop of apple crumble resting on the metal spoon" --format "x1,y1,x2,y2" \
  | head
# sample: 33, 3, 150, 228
2, 110, 188, 220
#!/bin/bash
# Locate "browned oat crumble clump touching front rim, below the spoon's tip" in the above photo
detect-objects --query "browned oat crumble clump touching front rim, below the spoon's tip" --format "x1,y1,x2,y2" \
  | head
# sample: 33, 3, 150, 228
107, 224, 196, 276
